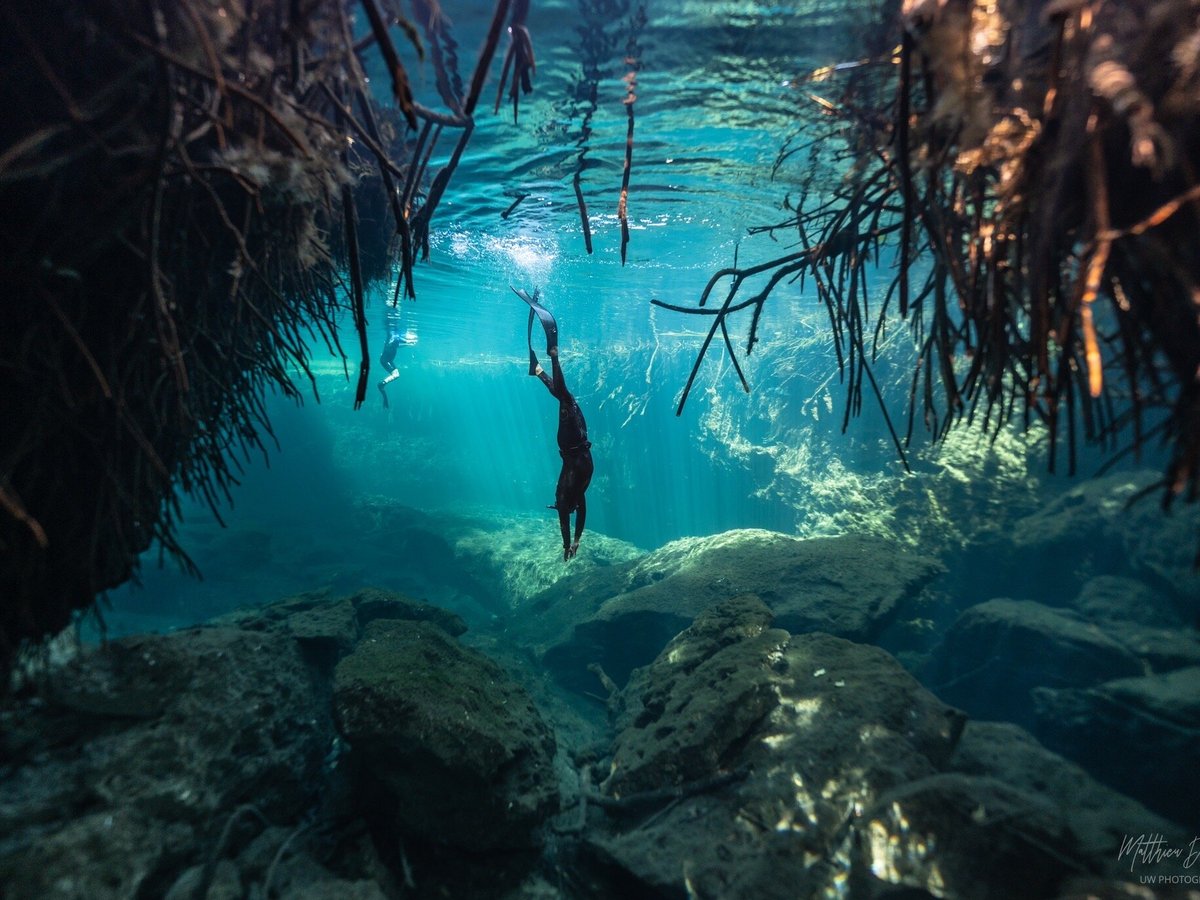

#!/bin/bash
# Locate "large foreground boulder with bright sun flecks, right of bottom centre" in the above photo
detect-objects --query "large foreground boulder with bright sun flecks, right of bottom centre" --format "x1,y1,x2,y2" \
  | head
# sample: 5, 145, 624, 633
587, 595, 962, 899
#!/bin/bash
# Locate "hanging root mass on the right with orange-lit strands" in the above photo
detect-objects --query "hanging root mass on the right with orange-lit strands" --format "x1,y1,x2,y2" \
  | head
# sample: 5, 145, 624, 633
660, 0, 1200, 549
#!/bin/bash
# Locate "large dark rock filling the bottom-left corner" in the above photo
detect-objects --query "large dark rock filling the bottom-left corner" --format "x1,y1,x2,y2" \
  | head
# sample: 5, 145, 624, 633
0, 628, 334, 898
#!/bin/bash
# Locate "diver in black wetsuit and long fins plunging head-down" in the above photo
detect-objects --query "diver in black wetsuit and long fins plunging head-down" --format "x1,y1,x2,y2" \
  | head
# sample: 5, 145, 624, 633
512, 288, 593, 562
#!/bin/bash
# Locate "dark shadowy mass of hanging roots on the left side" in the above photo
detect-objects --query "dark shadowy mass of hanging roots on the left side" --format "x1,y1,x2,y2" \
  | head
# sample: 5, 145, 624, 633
0, 0, 532, 690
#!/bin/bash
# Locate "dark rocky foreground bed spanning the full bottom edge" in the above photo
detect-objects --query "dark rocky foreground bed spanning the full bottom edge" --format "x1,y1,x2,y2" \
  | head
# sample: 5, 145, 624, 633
0, 580, 1195, 900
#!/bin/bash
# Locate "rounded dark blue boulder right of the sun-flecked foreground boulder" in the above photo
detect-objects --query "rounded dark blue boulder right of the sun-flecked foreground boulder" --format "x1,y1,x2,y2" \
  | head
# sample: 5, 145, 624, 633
926, 599, 1145, 725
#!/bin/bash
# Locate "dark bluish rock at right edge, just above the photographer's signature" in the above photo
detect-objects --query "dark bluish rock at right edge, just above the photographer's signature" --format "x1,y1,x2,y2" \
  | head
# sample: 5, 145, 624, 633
1033, 667, 1200, 828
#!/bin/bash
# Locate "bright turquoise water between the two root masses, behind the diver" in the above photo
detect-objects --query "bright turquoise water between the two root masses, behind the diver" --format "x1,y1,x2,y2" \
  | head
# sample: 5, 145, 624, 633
108, 2, 1156, 631
